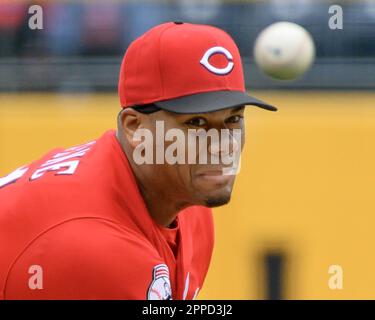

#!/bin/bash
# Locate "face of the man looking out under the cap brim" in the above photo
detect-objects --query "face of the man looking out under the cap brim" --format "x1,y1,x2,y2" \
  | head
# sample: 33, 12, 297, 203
134, 107, 245, 207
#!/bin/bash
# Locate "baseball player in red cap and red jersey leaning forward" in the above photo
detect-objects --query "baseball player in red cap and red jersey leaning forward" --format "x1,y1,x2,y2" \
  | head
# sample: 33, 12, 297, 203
0, 22, 276, 300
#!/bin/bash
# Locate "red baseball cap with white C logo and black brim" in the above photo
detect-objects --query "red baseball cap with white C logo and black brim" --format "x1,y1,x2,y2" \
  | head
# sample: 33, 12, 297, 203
118, 22, 277, 113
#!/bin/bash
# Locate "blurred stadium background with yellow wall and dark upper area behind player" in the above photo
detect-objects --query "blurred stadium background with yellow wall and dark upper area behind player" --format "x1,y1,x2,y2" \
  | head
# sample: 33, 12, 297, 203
0, 0, 375, 299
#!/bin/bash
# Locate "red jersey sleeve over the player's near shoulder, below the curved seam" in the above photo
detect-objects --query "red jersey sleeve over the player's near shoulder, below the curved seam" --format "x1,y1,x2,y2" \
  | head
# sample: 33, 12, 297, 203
4, 218, 164, 299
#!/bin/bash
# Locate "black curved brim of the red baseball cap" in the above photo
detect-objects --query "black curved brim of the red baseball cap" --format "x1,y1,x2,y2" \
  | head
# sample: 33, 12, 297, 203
154, 90, 277, 113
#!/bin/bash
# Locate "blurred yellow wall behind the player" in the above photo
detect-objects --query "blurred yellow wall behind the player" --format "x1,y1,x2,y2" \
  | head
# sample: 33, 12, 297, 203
0, 91, 375, 299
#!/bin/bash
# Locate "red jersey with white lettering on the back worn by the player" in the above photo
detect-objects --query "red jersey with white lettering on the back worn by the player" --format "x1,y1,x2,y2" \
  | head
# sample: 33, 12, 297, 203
0, 130, 214, 299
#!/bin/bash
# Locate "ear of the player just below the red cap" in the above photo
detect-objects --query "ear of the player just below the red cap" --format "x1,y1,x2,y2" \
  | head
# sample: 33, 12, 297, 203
119, 108, 143, 148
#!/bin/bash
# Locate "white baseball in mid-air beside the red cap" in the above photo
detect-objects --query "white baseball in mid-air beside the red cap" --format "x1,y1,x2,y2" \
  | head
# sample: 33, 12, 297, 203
254, 22, 315, 80
